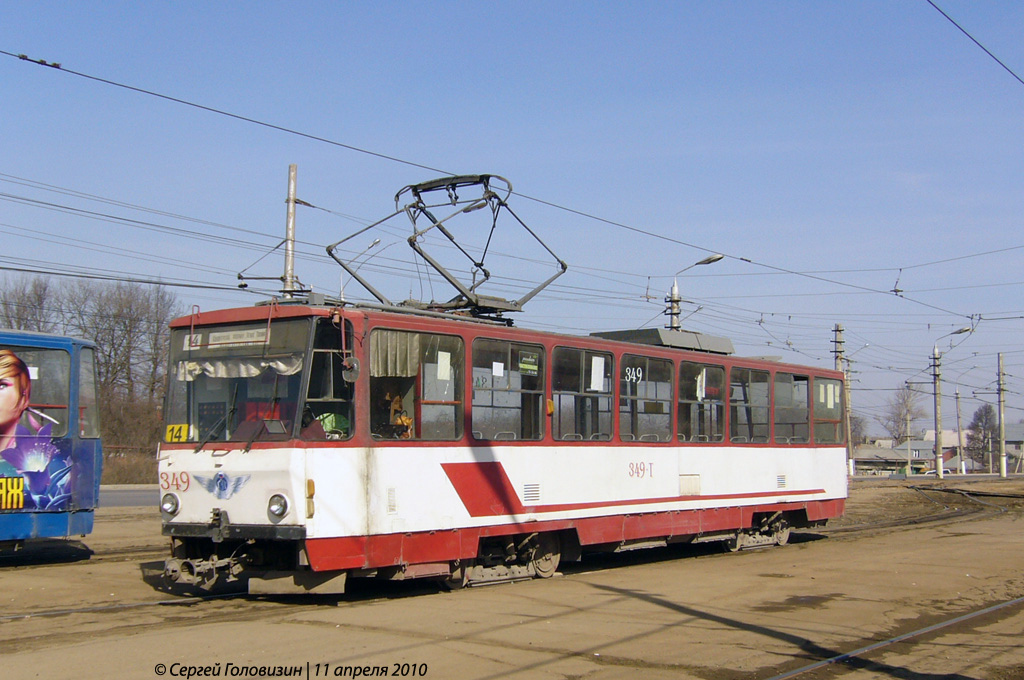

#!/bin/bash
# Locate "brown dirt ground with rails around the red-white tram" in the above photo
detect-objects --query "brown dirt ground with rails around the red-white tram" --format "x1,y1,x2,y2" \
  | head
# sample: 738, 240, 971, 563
0, 478, 1024, 680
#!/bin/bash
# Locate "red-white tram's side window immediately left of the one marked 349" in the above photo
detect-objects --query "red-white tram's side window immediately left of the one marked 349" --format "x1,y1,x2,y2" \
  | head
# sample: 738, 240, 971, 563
551, 347, 611, 441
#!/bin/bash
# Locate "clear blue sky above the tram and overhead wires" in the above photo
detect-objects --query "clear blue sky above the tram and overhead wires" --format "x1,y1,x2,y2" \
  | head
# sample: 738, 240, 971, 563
0, 0, 1024, 436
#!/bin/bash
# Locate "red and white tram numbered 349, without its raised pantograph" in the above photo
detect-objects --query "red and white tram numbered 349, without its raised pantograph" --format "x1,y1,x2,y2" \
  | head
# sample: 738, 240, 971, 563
159, 303, 847, 593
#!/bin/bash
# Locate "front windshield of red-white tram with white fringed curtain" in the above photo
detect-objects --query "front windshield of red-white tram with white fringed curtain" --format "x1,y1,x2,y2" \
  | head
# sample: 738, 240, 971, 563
165, 318, 311, 445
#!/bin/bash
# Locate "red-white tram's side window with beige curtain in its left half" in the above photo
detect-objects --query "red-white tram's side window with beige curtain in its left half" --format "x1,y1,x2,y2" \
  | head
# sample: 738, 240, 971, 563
370, 330, 465, 440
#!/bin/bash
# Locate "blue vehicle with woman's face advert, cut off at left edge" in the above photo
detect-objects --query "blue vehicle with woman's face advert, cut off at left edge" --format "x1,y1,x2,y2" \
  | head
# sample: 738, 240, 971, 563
0, 329, 103, 551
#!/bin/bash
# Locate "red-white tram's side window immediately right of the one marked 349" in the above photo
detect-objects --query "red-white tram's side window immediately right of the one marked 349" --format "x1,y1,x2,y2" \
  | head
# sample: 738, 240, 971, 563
678, 362, 725, 441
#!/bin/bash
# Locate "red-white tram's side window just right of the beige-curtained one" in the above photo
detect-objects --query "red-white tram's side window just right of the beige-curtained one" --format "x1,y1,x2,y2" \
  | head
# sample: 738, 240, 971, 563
471, 338, 544, 440
